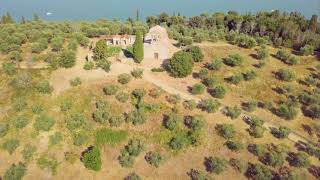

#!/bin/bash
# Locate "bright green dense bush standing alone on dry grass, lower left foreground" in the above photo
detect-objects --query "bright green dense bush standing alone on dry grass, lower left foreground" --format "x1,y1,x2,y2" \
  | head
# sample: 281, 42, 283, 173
81, 146, 102, 171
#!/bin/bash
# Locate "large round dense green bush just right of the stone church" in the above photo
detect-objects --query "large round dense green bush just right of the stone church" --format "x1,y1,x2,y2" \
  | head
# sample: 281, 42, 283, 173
168, 51, 193, 78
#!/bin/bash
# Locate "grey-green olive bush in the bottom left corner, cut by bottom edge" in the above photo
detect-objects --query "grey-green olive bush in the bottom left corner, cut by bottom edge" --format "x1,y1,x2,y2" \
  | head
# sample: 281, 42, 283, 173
3, 162, 27, 180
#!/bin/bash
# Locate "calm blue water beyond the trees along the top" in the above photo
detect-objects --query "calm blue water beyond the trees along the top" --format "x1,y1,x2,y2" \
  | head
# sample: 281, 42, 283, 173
0, 0, 320, 20
